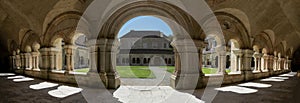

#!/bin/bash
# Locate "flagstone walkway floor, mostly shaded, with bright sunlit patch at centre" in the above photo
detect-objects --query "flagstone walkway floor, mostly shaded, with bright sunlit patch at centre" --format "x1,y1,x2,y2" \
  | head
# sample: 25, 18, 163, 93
0, 72, 300, 103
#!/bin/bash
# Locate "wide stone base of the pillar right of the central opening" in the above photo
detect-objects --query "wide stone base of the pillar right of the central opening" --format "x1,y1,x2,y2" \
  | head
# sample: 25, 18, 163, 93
171, 74, 204, 90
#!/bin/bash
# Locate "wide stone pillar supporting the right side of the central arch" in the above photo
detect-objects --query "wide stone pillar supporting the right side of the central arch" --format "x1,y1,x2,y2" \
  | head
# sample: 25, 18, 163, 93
171, 39, 202, 90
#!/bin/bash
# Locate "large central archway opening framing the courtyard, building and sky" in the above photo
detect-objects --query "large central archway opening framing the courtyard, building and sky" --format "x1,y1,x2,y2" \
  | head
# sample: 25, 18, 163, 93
116, 16, 175, 86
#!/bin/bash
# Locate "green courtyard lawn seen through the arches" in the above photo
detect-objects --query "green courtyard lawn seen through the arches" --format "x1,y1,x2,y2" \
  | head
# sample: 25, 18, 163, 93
75, 66, 230, 78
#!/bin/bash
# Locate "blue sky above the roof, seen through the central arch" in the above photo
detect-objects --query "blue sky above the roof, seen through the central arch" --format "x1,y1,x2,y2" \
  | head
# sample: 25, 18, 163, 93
118, 16, 173, 38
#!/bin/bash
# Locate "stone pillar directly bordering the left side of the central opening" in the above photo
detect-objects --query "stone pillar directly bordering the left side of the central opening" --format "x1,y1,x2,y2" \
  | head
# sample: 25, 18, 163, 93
102, 39, 120, 89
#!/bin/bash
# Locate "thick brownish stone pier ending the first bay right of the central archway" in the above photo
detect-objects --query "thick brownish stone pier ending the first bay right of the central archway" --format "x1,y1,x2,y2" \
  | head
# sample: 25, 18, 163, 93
241, 50, 253, 81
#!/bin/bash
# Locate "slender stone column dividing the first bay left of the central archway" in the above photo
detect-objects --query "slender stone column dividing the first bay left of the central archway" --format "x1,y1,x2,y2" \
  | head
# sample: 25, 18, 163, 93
64, 45, 75, 73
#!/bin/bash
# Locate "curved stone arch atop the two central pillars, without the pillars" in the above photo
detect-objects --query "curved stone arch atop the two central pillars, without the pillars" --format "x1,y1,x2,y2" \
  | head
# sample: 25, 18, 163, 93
98, 1, 205, 40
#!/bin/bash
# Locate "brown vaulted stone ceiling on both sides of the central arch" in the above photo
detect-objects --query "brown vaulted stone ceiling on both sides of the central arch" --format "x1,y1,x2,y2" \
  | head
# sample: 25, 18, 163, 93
0, 0, 300, 55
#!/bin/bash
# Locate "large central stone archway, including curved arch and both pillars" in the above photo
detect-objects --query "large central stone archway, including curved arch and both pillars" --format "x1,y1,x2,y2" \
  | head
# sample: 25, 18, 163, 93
97, 1, 204, 89
